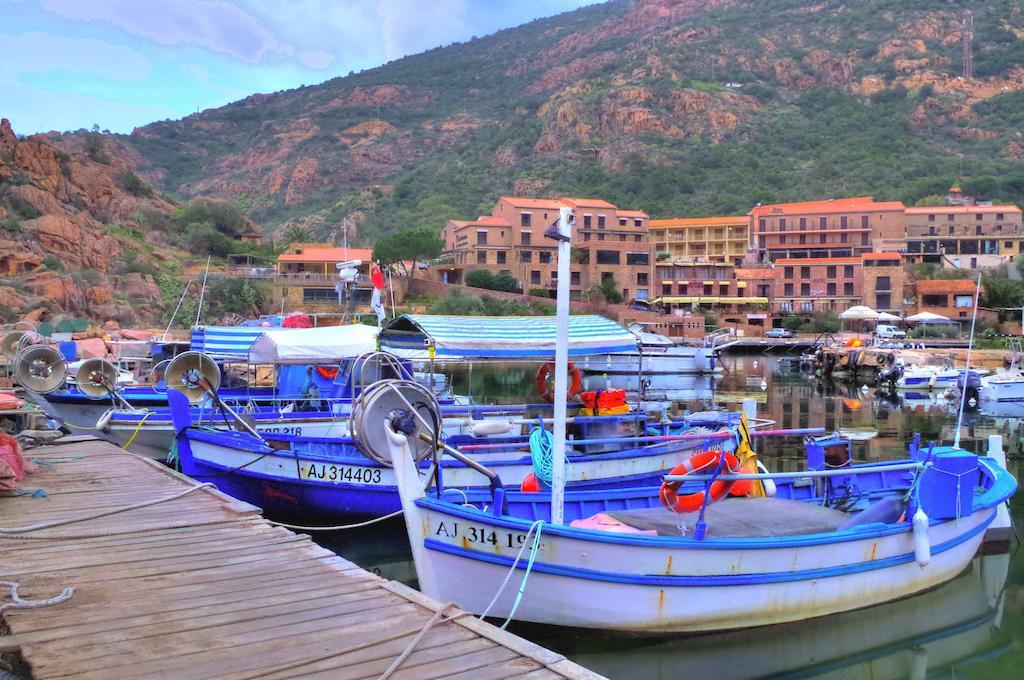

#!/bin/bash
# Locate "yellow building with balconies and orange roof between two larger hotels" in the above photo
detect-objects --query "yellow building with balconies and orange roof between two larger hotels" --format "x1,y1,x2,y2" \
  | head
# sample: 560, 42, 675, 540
650, 215, 751, 265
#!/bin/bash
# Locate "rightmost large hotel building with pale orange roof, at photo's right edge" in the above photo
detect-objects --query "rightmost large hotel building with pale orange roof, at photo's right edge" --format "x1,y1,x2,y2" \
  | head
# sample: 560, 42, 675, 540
901, 205, 1024, 269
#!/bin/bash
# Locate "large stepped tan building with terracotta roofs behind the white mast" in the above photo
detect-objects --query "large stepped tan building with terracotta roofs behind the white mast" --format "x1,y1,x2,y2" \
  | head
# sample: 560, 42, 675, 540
438, 196, 653, 300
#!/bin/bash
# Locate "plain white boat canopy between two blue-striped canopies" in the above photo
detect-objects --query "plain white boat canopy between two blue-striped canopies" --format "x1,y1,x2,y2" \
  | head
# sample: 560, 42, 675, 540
249, 324, 377, 364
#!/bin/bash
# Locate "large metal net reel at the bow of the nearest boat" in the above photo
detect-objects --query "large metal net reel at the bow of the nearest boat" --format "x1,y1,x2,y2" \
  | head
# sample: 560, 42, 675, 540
351, 380, 440, 467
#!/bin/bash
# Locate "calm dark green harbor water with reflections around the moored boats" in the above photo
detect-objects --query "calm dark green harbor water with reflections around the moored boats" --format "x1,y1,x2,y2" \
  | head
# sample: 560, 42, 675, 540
317, 354, 1024, 680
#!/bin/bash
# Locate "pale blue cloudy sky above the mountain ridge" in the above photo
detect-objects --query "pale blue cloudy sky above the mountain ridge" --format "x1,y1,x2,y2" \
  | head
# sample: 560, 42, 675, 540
0, 0, 595, 134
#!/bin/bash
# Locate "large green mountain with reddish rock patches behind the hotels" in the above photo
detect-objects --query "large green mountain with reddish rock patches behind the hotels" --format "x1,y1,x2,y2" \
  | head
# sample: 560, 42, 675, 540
70, 0, 1024, 243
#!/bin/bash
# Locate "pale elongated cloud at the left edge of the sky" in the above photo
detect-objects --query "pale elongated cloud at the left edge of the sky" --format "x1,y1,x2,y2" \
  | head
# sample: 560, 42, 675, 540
0, 32, 152, 83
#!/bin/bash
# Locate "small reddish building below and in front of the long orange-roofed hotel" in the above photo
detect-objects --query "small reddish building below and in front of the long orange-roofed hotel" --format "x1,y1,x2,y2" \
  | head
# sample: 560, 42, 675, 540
771, 256, 863, 317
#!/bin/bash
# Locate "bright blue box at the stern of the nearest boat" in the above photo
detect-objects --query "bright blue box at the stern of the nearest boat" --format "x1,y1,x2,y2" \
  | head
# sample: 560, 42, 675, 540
918, 447, 979, 519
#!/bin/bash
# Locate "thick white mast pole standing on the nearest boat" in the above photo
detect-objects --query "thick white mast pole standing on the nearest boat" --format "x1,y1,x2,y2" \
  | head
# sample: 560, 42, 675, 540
551, 208, 572, 524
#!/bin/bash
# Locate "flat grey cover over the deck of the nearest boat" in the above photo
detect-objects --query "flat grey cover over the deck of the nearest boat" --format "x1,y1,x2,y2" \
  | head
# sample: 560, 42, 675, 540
605, 498, 850, 539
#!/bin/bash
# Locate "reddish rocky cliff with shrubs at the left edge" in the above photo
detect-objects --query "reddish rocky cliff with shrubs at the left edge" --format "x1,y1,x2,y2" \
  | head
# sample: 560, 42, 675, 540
0, 119, 173, 324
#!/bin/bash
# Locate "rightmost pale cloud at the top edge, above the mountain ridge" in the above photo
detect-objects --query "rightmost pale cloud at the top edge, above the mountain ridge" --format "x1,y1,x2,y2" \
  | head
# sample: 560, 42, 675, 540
377, 0, 473, 59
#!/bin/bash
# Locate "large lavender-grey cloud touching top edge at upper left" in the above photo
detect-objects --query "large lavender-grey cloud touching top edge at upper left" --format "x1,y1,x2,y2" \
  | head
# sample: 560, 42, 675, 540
42, 0, 319, 66
